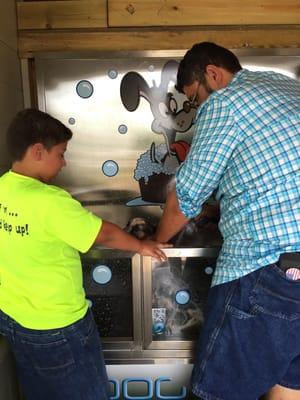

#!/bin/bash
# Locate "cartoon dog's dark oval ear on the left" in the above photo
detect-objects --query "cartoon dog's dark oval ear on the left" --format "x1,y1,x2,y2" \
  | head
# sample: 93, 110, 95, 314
120, 71, 151, 111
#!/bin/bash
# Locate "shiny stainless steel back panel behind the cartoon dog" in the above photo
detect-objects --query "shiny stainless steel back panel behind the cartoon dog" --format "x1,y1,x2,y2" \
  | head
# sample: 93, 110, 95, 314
36, 49, 300, 231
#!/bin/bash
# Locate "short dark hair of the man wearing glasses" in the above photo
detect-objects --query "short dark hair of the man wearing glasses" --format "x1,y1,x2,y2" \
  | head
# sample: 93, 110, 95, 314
175, 42, 242, 93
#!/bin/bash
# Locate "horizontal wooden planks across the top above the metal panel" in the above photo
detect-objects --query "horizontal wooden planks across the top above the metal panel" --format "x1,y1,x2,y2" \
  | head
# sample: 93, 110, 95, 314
17, 0, 300, 58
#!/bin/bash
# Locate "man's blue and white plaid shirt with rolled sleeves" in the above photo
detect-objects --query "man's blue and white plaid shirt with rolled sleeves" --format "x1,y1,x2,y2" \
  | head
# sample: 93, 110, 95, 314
176, 69, 300, 285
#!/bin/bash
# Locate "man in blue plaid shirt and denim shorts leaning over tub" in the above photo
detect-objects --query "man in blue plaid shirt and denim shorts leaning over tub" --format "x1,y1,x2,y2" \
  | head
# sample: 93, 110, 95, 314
156, 42, 300, 400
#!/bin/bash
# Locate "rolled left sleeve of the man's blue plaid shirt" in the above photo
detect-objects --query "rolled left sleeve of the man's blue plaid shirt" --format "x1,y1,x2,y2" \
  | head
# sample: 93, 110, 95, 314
176, 95, 238, 218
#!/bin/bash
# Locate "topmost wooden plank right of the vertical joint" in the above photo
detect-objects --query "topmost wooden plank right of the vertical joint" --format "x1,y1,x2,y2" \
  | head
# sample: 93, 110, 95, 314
108, 0, 300, 27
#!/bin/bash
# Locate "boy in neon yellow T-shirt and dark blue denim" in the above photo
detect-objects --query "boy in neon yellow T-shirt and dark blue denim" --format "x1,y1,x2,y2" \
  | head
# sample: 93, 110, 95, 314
0, 109, 166, 400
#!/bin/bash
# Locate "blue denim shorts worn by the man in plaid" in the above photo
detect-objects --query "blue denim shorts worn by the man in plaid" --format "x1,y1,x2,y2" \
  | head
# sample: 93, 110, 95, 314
192, 264, 300, 400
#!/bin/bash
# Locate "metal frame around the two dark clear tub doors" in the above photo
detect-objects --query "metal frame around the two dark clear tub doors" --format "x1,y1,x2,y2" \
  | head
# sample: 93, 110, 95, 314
82, 246, 219, 364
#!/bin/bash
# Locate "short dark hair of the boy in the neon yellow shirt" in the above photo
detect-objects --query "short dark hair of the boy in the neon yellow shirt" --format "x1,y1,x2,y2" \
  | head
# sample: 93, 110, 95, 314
6, 108, 72, 161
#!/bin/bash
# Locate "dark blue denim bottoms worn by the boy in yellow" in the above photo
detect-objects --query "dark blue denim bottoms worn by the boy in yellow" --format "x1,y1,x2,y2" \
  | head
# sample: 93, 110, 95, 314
0, 310, 109, 400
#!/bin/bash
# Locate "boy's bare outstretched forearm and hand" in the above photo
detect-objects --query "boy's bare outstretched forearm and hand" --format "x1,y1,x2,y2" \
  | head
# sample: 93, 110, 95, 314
94, 221, 170, 261
